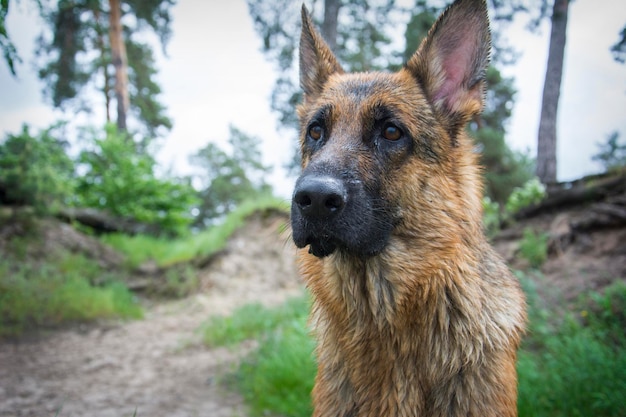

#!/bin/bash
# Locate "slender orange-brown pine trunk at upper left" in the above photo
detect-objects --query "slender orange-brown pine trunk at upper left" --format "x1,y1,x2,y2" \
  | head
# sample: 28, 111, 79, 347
109, 0, 130, 131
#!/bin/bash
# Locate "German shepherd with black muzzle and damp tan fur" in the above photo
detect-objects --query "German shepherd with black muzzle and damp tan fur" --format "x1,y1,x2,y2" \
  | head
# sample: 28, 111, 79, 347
291, 0, 526, 417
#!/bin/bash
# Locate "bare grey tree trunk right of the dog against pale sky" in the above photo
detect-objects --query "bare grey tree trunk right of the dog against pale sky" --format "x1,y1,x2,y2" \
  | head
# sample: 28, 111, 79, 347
536, 0, 569, 185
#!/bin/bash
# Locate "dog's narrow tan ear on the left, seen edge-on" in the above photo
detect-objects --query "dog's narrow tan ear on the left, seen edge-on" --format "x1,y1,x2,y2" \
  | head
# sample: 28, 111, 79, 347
300, 4, 343, 102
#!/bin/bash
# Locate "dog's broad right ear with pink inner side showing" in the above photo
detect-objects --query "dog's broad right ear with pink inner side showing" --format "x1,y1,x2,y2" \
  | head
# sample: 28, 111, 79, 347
406, 0, 491, 133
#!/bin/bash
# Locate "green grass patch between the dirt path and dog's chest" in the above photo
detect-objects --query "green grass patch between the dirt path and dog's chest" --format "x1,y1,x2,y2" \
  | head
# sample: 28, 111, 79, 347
202, 296, 316, 417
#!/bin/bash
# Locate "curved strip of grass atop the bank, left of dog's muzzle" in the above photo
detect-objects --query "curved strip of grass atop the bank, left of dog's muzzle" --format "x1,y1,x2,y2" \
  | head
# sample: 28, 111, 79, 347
102, 197, 287, 268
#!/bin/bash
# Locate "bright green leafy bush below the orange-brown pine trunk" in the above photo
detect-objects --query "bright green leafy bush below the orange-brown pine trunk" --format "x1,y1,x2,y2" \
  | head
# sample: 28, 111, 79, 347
76, 125, 197, 234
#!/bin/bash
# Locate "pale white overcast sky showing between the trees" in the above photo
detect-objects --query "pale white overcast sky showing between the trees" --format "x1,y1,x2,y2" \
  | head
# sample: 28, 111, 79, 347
0, 0, 626, 198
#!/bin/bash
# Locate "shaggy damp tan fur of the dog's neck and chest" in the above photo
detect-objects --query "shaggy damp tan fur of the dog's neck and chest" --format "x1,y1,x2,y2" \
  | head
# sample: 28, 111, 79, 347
301, 240, 525, 417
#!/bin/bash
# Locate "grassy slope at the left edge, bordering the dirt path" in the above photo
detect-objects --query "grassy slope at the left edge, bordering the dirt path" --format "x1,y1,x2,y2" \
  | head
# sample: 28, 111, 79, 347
0, 249, 142, 337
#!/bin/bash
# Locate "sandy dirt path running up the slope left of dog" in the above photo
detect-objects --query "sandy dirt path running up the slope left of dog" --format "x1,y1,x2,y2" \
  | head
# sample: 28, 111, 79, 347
0, 214, 301, 417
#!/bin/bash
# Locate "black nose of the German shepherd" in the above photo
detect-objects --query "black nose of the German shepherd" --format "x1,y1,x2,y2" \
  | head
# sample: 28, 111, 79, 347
293, 176, 346, 219
